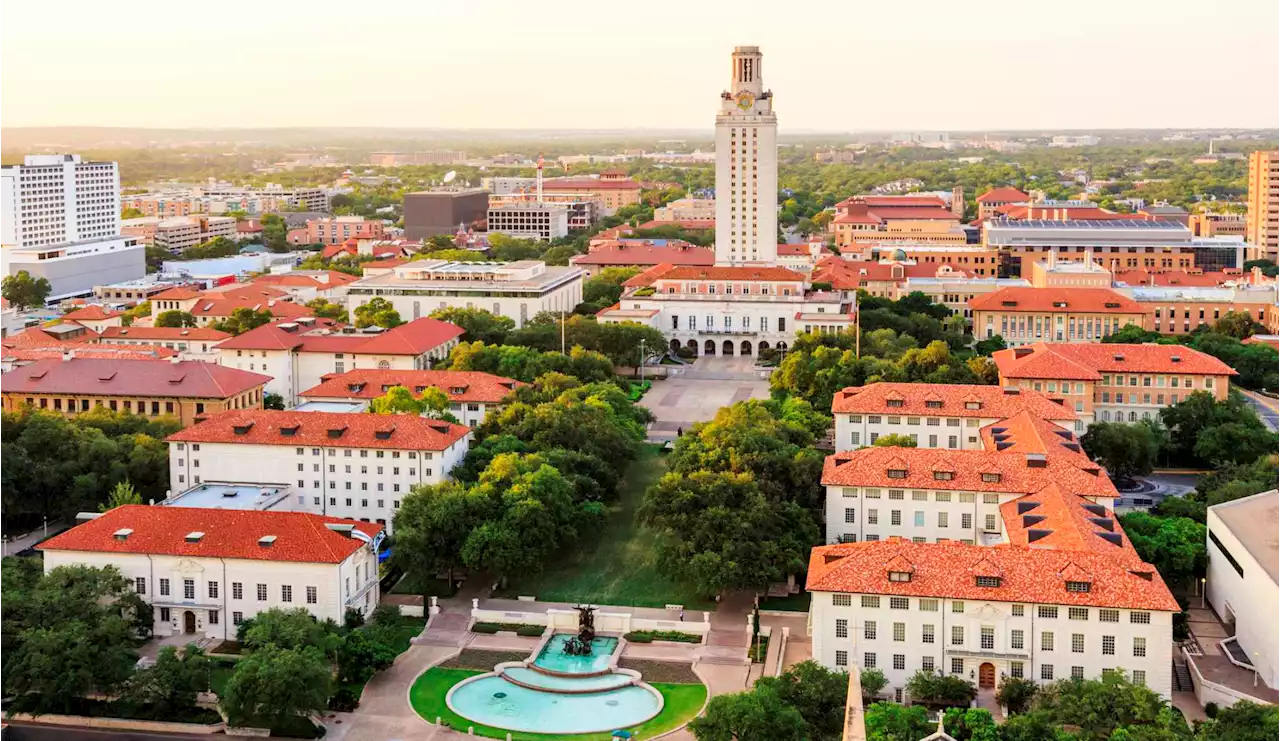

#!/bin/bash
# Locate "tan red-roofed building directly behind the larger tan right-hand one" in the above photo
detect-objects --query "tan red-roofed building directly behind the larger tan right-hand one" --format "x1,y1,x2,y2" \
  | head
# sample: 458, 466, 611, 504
969, 288, 1147, 347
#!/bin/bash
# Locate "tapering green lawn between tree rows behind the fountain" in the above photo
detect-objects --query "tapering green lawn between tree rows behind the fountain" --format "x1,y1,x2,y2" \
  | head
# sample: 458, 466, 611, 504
502, 445, 714, 610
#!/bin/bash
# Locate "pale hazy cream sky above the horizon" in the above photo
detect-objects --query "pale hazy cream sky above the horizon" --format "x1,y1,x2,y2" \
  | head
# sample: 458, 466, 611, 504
0, 0, 1280, 131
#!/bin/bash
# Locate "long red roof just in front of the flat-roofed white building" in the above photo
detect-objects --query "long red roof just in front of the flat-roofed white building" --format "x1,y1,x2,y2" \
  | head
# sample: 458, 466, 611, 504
218, 316, 463, 356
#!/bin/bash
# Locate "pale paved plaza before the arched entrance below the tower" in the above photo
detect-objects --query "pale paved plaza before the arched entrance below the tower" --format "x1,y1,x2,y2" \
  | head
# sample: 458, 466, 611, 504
640, 357, 769, 440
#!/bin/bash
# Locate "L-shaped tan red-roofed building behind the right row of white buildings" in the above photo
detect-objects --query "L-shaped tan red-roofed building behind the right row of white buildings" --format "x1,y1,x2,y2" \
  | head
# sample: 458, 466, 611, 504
992, 342, 1236, 427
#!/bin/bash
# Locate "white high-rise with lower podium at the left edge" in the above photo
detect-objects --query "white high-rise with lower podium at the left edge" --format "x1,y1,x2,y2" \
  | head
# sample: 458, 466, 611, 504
0, 155, 146, 299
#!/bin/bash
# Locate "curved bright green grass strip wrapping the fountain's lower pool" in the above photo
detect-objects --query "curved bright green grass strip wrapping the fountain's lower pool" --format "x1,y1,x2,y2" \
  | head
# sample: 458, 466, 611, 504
408, 667, 707, 741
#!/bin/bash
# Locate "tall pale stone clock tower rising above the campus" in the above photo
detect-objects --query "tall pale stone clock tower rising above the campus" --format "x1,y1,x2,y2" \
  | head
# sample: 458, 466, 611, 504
716, 46, 778, 265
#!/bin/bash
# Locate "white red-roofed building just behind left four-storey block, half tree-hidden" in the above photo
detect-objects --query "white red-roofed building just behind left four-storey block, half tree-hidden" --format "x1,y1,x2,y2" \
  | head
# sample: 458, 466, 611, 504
298, 369, 526, 427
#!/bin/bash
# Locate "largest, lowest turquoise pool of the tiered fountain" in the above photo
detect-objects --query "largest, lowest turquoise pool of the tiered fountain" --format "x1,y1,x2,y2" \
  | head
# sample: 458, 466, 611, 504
445, 669, 663, 733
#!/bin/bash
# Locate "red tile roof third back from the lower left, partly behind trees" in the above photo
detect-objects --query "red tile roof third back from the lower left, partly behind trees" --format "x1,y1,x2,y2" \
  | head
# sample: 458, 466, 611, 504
300, 370, 526, 404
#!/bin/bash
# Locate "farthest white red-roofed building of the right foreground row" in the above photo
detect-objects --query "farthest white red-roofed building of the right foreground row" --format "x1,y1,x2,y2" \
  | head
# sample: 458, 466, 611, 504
831, 383, 1084, 450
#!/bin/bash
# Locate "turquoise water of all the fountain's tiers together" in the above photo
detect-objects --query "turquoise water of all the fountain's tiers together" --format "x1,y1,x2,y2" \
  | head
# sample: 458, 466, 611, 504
445, 633, 663, 733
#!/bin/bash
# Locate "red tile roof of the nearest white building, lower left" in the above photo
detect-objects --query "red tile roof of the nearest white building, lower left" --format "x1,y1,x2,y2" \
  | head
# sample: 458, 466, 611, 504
37, 504, 383, 563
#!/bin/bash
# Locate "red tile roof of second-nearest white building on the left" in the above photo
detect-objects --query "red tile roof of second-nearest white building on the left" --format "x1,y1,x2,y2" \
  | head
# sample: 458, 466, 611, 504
165, 410, 471, 450
